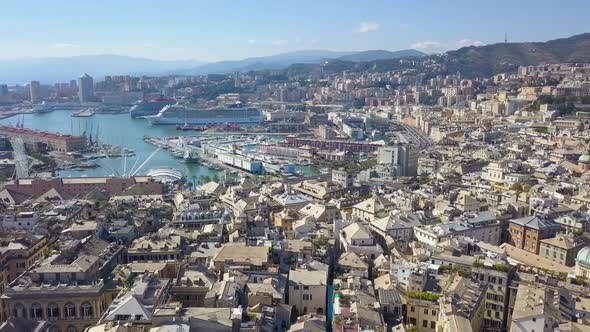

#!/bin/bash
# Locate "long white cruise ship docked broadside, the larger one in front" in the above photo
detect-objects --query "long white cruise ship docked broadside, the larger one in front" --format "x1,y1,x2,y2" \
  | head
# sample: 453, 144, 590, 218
146, 105, 262, 125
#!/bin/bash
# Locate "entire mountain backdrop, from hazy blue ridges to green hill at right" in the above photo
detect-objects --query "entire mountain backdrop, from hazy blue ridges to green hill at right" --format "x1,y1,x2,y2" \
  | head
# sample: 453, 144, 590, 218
0, 33, 590, 84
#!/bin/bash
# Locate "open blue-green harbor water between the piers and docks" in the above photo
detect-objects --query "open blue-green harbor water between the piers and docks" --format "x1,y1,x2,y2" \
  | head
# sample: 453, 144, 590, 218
0, 110, 220, 181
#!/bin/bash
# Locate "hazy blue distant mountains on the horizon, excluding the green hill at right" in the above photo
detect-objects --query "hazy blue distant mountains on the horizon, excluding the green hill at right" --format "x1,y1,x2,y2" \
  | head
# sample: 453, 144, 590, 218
0, 50, 426, 84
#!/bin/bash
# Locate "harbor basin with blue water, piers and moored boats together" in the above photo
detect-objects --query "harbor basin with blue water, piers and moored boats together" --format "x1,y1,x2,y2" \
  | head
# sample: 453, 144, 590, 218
0, 109, 317, 179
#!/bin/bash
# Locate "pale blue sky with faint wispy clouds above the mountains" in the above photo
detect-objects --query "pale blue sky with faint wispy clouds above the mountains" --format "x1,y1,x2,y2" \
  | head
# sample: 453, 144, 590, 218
0, 0, 590, 61
